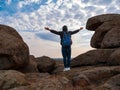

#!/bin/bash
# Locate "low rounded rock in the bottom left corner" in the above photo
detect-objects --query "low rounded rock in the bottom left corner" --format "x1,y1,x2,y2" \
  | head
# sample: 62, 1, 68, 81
0, 70, 28, 90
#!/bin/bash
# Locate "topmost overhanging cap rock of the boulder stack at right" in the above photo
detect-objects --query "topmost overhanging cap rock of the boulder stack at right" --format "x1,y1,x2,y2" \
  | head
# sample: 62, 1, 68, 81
86, 14, 120, 31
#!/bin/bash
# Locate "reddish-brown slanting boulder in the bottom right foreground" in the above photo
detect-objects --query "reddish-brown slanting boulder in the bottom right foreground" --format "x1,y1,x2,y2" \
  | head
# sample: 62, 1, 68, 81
73, 66, 120, 90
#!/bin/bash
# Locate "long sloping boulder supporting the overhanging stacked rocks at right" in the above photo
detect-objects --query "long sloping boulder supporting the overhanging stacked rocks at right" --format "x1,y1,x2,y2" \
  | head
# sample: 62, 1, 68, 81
71, 48, 120, 67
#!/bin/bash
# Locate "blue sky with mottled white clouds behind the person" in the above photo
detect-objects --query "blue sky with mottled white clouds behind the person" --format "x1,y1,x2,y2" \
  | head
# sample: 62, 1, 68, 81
0, 0, 120, 58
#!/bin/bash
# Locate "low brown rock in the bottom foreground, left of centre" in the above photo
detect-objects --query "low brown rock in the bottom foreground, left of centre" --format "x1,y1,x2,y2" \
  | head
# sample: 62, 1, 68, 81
10, 73, 73, 90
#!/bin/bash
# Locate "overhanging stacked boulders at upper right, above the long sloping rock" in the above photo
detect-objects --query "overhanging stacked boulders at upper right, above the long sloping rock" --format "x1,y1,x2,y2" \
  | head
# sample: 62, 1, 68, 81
86, 14, 120, 48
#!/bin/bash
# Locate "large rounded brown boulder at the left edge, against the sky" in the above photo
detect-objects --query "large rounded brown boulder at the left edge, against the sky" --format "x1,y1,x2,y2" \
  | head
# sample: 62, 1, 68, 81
0, 25, 29, 69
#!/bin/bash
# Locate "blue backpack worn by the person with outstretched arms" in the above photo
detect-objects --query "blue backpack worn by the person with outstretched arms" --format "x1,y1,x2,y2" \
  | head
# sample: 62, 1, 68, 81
62, 32, 72, 46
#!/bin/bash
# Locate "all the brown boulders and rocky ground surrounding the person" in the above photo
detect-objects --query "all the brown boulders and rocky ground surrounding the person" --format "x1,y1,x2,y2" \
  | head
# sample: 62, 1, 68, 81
0, 14, 120, 90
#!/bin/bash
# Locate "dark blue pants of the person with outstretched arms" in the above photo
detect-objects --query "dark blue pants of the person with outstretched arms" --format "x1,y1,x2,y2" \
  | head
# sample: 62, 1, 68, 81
62, 46, 71, 68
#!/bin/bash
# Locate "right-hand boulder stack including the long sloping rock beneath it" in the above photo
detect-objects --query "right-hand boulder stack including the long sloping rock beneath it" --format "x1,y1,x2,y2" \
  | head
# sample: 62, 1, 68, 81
71, 14, 120, 66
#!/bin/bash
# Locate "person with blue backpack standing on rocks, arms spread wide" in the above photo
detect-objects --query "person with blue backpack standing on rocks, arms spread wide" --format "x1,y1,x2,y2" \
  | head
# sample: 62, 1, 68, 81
45, 25, 83, 71
